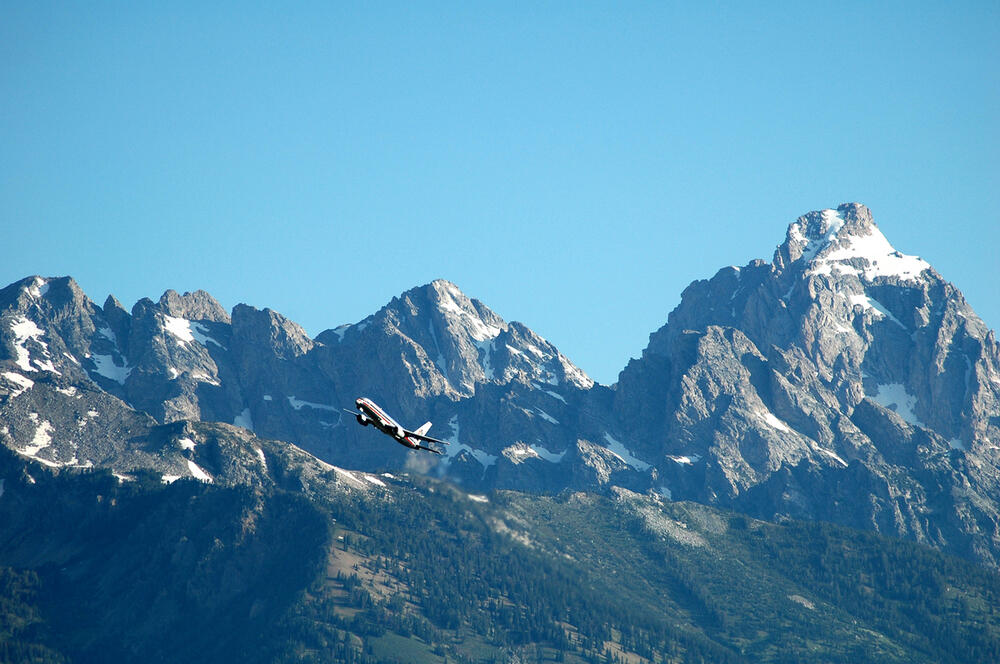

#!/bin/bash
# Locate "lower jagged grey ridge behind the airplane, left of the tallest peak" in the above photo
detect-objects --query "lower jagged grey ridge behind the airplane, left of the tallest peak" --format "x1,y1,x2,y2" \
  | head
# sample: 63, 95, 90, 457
0, 277, 611, 490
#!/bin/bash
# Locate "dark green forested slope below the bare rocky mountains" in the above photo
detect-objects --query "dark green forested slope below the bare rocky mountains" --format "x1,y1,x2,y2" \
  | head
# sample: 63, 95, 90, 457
0, 452, 1000, 663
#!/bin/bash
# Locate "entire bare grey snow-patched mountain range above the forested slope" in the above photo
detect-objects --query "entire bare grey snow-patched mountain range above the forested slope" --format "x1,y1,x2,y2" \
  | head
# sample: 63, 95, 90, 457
0, 204, 1000, 564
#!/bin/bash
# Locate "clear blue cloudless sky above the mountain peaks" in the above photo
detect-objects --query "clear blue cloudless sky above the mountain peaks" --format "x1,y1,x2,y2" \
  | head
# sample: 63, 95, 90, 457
0, 1, 1000, 384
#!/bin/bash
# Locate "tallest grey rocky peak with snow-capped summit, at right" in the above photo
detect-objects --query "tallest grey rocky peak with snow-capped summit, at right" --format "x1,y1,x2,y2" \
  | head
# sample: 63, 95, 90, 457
615, 204, 1000, 563
